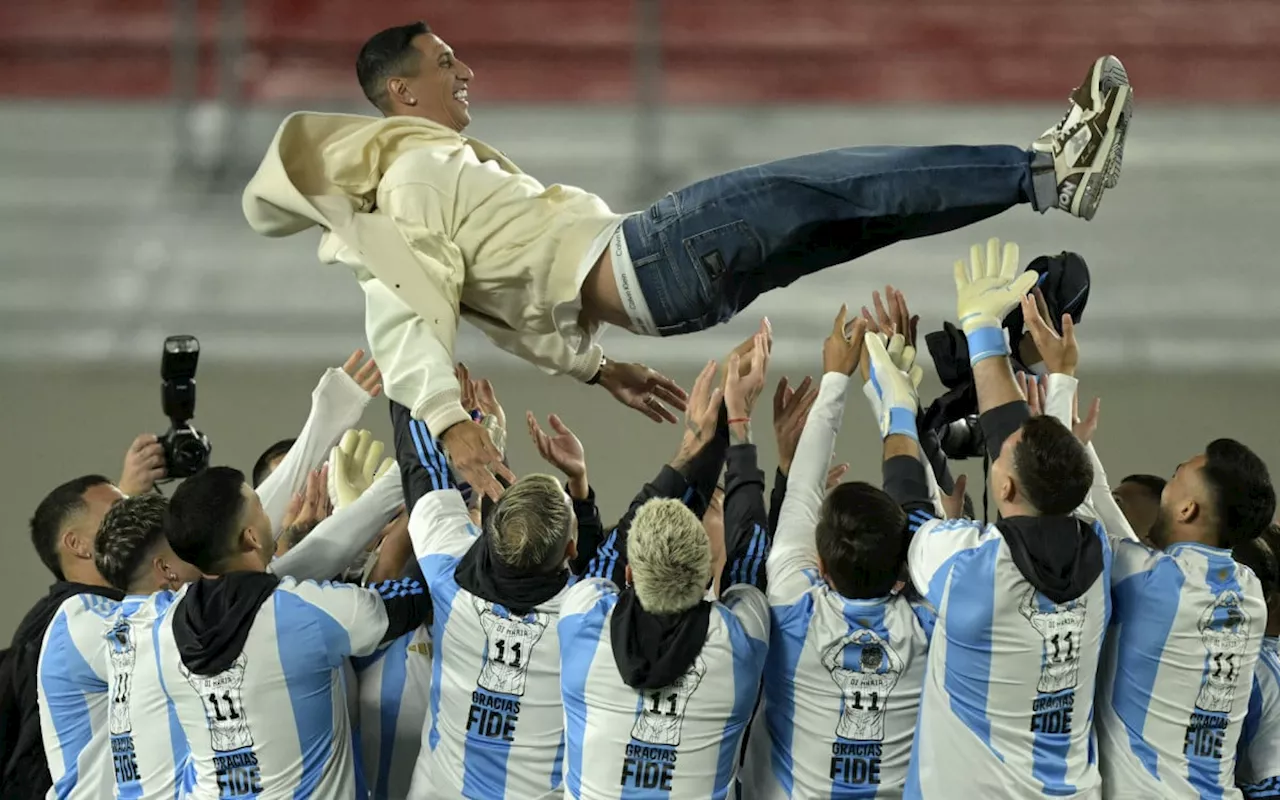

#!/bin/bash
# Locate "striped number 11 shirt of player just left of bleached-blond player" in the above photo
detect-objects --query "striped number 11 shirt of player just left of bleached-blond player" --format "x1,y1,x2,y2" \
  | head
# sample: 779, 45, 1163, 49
408, 489, 564, 800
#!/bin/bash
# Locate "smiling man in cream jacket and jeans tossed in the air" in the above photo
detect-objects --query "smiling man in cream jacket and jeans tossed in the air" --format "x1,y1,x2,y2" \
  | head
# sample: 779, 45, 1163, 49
244, 23, 1132, 494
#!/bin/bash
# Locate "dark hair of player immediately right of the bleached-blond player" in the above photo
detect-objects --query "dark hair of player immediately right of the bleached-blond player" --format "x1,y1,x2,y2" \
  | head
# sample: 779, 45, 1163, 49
814, 481, 906, 599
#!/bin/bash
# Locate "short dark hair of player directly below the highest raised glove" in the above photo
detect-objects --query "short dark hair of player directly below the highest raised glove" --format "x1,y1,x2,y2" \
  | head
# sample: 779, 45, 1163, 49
1014, 416, 1093, 517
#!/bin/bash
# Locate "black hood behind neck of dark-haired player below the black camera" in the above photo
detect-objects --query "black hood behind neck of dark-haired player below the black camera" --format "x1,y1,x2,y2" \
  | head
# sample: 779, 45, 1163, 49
173, 572, 280, 675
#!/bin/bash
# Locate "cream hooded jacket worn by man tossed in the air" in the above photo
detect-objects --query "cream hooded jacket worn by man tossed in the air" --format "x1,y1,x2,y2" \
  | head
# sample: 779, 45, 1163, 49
243, 111, 623, 435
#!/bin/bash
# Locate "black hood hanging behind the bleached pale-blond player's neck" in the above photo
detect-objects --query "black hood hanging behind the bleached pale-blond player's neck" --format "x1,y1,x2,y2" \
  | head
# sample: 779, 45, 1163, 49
609, 589, 712, 689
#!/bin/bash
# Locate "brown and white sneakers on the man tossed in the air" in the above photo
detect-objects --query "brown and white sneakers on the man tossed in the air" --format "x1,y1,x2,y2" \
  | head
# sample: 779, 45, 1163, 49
1032, 55, 1133, 219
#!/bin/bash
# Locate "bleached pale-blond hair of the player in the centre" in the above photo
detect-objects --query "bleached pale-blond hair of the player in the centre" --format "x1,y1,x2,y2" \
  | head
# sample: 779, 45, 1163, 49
627, 499, 712, 614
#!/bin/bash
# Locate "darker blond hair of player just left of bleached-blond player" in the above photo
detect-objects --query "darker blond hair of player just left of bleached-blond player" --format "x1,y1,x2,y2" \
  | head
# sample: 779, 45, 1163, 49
488, 475, 575, 571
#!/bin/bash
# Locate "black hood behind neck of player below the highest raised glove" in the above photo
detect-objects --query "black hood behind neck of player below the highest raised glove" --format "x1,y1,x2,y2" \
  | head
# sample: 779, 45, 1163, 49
996, 517, 1103, 603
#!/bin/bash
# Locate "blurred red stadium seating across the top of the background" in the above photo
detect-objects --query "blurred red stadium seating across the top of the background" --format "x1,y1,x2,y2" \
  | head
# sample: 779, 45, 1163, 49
0, 0, 1280, 104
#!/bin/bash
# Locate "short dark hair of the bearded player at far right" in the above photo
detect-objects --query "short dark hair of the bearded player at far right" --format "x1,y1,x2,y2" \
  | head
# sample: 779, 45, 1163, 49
1201, 439, 1276, 549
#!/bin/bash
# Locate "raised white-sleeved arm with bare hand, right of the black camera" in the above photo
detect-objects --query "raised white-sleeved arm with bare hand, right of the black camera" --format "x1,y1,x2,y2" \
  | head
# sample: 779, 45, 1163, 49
257, 349, 381, 536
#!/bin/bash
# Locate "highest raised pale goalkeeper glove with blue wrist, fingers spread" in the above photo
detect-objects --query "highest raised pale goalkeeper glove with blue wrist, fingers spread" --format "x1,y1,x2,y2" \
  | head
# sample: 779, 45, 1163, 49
955, 238, 1039, 364
